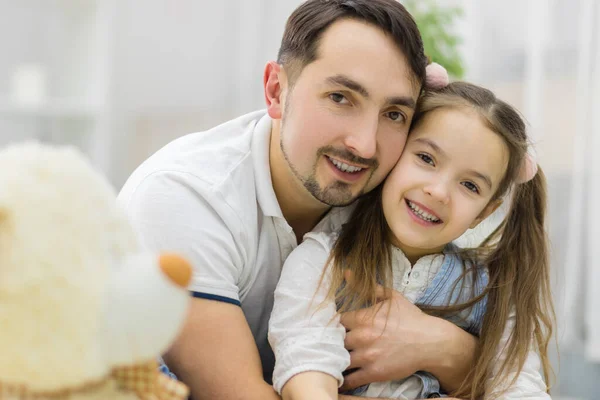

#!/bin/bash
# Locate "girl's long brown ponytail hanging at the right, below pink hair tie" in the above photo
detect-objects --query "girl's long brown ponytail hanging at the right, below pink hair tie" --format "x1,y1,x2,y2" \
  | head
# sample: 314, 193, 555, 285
459, 169, 555, 398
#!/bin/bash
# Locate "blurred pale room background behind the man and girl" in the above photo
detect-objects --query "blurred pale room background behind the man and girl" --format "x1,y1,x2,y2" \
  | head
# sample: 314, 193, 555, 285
0, 0, 600, 399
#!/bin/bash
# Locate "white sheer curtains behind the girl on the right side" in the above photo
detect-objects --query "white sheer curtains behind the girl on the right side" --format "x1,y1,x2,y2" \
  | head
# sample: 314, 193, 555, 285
460, 0, 600, 399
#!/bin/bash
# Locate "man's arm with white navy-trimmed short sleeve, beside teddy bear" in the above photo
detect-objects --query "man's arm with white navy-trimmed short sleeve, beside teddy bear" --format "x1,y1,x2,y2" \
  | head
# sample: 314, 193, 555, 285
121, 171, 279, 400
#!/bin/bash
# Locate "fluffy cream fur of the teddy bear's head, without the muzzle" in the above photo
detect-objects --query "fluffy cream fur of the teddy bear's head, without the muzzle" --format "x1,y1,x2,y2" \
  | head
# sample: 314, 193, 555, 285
0, 143, 139, 392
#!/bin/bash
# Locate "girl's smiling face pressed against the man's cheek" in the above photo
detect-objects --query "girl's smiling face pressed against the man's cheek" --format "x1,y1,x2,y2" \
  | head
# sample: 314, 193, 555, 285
382, 107, 509, 262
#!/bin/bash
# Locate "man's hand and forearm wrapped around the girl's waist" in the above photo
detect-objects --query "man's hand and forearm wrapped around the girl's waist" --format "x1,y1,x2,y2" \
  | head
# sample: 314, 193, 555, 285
341, 287, 477, 391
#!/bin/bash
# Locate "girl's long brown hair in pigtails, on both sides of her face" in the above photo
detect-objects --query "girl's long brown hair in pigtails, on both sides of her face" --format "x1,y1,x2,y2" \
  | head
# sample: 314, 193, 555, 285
327, 82, 555, 399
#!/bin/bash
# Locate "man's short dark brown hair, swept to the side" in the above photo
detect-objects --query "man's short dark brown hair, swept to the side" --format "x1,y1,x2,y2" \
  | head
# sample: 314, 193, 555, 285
277, 0, 428, 85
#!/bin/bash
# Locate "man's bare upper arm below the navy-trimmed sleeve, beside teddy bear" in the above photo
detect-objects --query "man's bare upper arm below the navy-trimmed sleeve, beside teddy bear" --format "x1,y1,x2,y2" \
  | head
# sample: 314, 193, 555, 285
164, 299, 279, 400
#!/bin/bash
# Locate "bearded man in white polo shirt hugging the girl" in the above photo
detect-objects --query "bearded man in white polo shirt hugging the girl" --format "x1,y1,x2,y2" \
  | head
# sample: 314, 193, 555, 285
119, 0, 475, 400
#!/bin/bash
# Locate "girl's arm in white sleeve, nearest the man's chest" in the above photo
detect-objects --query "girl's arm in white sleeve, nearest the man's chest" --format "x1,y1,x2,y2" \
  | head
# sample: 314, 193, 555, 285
269, 234, 350, 399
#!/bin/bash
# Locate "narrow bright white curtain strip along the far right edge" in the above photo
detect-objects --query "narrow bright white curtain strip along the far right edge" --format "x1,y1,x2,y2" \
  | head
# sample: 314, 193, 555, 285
565, 0, 600, 363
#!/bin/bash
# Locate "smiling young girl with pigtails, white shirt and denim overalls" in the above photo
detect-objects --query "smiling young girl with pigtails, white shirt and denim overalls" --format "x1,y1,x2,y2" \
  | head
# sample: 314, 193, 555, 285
269, 82, 554, 400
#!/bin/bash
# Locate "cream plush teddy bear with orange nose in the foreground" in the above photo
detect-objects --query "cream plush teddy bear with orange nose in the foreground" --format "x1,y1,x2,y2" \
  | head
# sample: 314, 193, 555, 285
0, 142, 191, 400
